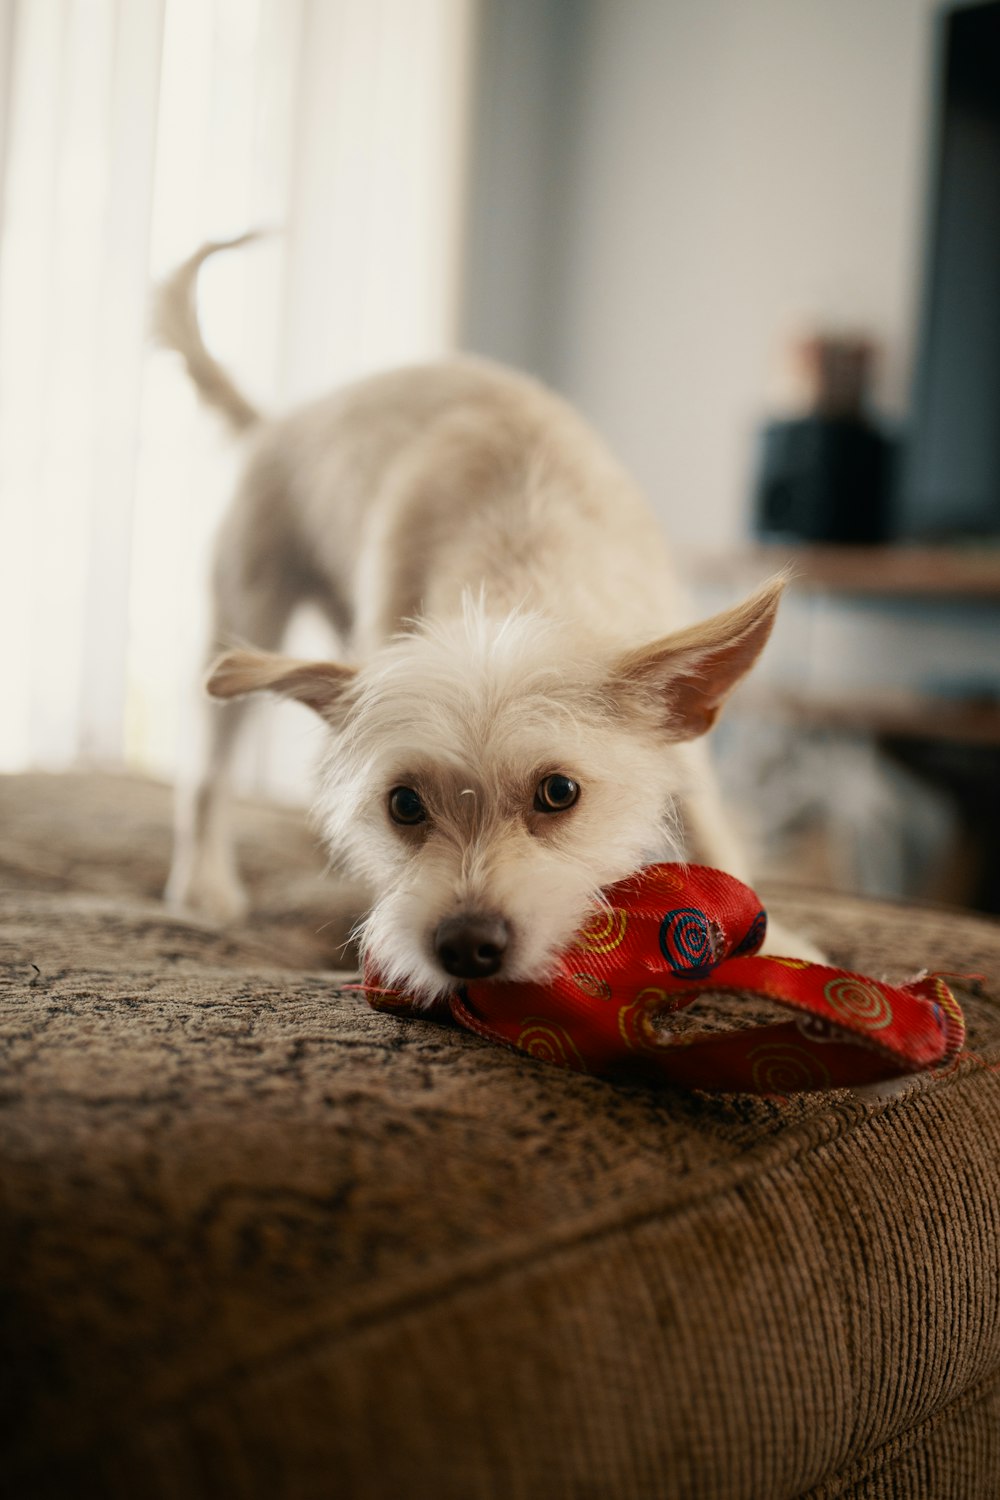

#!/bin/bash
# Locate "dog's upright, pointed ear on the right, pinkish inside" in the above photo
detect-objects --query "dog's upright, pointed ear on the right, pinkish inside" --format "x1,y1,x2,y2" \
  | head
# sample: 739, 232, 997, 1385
612, 576, 787, 740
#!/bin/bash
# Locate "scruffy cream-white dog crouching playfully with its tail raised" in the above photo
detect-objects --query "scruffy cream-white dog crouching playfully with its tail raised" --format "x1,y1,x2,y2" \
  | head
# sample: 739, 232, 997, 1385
159, 242, 804, 998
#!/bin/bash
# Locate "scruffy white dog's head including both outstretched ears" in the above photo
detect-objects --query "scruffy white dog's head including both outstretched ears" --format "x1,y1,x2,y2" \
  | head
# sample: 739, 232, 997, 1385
208, 581, 783, 999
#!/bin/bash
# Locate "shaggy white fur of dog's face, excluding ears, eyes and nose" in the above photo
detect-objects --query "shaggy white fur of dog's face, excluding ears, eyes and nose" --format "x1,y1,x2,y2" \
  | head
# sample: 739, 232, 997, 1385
316, 602, 687, 1001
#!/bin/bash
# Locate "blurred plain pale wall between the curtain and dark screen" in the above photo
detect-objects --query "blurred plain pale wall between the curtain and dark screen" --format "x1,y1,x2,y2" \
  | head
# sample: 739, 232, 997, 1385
465, 0, 934, 548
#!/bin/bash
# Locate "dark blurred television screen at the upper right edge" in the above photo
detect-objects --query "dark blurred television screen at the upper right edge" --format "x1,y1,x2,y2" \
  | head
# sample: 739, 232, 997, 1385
898, 0, 1000, 540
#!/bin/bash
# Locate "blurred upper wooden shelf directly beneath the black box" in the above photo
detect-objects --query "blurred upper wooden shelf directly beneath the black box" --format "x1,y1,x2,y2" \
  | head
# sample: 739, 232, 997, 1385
684, 543, 1000, 603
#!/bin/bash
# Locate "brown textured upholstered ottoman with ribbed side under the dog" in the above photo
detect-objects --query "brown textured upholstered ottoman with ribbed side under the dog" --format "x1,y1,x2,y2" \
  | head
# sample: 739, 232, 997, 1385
0, 777, 1000, 1500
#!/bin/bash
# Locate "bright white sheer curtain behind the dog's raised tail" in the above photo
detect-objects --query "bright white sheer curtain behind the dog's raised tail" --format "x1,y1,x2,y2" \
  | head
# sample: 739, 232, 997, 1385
0, 0, 474, 797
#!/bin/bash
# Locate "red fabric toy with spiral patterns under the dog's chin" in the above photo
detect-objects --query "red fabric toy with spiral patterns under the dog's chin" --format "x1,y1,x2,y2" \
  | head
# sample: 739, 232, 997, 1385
361, 864, 966, 1094
